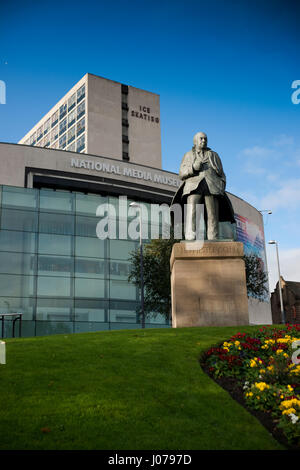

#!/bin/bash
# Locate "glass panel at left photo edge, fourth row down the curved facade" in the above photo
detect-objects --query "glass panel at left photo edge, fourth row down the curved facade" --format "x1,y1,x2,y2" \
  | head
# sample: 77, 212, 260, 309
0, 252, 36, 274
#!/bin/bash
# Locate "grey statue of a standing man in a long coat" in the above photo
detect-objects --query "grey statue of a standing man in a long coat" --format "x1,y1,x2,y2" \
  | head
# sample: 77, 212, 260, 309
172, 132, 235, 240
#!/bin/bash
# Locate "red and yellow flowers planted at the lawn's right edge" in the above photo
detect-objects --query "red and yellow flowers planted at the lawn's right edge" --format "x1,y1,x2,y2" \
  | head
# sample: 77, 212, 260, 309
203, 325, 300, 447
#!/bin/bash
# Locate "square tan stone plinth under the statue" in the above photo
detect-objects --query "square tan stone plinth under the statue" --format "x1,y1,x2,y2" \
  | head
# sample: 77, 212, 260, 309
170, 241, 249, 328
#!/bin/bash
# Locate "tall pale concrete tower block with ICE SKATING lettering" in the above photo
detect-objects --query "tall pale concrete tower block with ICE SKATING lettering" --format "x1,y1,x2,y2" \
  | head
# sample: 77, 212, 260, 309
19, 73, 161, 168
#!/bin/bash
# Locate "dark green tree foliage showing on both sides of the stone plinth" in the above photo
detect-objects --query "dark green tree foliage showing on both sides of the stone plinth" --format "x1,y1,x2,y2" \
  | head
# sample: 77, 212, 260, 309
128, 241, 268, 319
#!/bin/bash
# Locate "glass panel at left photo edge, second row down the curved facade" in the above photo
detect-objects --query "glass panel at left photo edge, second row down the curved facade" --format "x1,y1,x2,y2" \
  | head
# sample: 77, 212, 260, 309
1, 209, 38, 232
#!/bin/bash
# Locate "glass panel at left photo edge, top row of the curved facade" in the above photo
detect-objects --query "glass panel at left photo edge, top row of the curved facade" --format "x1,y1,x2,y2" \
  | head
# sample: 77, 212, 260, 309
2, 186, 38, 209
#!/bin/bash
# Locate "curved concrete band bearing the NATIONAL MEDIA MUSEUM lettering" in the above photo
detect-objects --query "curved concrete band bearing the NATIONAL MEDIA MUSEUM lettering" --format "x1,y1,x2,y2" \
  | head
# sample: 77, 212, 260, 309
0, 143, 180, 194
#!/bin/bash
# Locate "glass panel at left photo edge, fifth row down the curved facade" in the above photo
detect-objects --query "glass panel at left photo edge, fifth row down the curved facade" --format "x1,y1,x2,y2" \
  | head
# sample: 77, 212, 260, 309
0, 274, 34, 297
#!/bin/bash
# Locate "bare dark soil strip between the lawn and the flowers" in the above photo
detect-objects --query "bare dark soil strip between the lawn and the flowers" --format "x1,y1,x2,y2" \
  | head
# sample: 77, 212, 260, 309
199, 355, 299, 451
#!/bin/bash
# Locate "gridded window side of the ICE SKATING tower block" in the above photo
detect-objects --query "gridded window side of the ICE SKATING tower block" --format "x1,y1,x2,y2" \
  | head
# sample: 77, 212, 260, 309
24, 81, 86, 153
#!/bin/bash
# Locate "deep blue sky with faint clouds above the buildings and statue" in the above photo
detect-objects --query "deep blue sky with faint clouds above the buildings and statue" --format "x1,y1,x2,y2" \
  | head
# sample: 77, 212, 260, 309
0, 0, 300, 288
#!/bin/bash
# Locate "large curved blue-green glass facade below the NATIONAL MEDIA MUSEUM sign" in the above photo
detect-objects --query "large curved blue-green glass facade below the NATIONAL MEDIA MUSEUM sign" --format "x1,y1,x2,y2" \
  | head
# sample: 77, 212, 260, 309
0, 186, 169, 336
